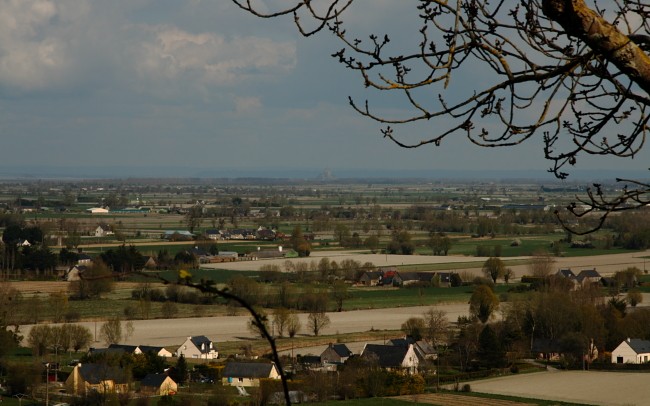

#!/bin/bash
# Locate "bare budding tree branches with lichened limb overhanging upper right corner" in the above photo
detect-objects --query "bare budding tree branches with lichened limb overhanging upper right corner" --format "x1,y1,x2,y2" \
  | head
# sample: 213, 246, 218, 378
233, 0, 650, 232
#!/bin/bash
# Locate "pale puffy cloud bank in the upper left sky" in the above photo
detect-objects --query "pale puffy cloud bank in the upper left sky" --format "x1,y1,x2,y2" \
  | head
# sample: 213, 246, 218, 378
0, 0, 296, 98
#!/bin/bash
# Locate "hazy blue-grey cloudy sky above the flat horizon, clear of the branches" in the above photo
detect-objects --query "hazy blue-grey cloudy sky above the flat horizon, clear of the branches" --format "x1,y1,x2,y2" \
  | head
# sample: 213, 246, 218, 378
0, 0, 648, 179
